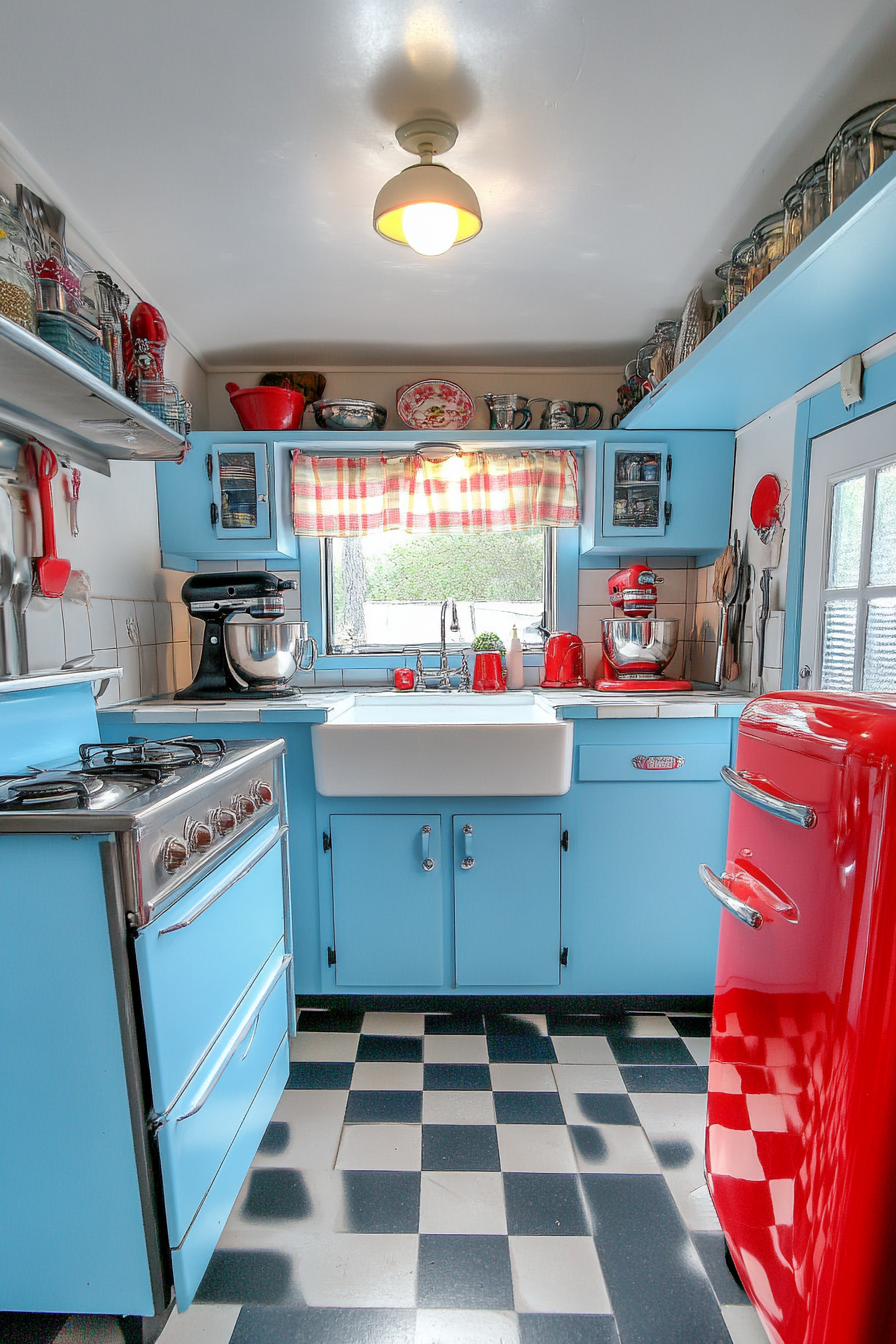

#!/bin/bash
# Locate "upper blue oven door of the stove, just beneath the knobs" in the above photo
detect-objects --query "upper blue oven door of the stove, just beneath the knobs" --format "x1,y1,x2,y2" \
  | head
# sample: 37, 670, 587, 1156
136, 820, 283, 1114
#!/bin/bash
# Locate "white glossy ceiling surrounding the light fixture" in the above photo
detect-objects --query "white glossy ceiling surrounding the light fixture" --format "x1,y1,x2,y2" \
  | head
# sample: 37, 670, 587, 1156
0, 0, 896, 368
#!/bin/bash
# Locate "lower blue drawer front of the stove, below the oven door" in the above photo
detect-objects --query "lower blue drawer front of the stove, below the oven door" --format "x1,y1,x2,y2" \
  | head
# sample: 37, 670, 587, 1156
159, 942, 289, 1246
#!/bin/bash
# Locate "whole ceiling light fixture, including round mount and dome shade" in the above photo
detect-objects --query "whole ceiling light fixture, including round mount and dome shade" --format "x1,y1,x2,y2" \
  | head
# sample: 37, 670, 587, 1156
373, 120, 482, 257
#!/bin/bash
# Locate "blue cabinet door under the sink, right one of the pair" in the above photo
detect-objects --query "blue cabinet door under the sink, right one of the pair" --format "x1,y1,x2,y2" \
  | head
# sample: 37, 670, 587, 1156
454, 813, 560, 986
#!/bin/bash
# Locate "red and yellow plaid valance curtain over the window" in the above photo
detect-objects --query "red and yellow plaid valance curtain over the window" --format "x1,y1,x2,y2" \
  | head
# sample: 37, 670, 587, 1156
293, 450, 579, 536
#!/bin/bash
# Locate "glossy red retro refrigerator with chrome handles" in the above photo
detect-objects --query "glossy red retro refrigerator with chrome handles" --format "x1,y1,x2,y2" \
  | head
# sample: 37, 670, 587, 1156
700, 691, 896, 1344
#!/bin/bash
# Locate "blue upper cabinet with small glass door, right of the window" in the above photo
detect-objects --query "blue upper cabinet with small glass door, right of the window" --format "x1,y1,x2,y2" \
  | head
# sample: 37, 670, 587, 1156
582, 429, 735, 560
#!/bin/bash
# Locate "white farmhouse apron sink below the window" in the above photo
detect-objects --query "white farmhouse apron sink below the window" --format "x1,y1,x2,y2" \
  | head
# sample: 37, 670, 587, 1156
312, 691, 572, 798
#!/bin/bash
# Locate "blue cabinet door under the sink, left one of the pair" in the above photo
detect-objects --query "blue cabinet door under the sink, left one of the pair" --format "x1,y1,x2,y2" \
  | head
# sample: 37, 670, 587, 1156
330, 813, 445, 988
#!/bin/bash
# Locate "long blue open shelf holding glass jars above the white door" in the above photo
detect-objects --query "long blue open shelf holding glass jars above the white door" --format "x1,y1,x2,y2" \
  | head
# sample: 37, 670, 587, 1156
628, 156, 896, 430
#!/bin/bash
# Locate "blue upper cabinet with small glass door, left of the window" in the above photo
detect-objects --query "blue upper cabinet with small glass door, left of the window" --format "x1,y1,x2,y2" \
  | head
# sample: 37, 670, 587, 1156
156, 431, 298, 570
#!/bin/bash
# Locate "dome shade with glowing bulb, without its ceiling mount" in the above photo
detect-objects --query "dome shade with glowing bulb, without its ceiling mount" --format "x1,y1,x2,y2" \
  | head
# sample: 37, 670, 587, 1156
373, 164, 482, 257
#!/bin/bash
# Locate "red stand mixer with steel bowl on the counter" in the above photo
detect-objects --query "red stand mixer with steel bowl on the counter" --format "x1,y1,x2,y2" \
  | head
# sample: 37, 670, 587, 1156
595, 564, 693, 692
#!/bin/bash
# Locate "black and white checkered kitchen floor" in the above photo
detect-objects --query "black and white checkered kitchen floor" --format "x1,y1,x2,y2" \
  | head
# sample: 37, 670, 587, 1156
163, 1009, 764, 1344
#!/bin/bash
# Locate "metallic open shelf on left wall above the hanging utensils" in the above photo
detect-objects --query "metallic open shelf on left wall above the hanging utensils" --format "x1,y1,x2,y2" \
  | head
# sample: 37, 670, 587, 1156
0, 316, 185, 476
